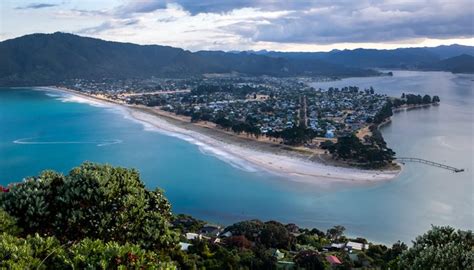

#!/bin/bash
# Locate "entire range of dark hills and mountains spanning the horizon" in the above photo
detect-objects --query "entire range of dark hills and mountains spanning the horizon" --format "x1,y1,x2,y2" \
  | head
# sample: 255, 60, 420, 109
0, 32, 474, 86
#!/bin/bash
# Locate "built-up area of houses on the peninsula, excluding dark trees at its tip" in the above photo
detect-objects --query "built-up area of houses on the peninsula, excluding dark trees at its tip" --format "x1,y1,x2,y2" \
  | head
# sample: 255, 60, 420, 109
59, 77, 389, 142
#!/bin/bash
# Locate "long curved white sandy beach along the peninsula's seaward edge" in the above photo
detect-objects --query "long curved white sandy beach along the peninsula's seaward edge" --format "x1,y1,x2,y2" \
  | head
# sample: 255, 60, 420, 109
39, 86, 401, 184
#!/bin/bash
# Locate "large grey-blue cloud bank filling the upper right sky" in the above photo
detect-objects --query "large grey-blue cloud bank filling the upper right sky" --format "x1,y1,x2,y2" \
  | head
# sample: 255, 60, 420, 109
223, 0, 474, 44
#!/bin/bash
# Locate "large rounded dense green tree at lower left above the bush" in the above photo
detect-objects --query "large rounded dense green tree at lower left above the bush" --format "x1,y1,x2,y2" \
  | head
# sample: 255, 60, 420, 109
0, 163, 178, 250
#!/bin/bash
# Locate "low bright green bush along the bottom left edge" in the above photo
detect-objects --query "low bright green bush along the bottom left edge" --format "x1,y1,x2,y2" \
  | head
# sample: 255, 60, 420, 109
0, 233, 176, 269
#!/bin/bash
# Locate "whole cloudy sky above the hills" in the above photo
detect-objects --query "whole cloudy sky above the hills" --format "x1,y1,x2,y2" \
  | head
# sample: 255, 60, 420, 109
0, 0, 474, 51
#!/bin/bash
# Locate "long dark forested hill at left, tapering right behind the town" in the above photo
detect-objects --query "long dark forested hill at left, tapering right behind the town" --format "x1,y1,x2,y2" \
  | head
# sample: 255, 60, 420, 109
0, 33, 378, 85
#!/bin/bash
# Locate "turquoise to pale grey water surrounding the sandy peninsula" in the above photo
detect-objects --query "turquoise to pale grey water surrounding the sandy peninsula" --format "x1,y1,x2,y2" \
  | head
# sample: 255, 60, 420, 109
0, 71, 474, 243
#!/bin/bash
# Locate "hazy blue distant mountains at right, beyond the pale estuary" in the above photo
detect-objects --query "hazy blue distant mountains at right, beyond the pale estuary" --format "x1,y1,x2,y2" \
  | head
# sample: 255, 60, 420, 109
253, 44, 474, 73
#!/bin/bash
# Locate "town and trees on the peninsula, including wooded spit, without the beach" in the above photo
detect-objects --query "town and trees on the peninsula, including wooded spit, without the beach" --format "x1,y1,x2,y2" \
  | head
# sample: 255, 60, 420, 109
59, 75, 439, 169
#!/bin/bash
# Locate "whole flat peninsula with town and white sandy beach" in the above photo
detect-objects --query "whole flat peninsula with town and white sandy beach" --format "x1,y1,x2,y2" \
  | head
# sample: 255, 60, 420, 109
42, 76, 410, 183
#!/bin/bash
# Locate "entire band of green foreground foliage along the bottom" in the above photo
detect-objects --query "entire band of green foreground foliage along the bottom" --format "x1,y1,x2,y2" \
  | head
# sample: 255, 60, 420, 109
0, 163, 474, 269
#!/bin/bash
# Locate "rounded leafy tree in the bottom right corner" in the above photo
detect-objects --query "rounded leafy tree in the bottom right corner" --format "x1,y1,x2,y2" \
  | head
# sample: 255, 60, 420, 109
399, 226, 474, 270
